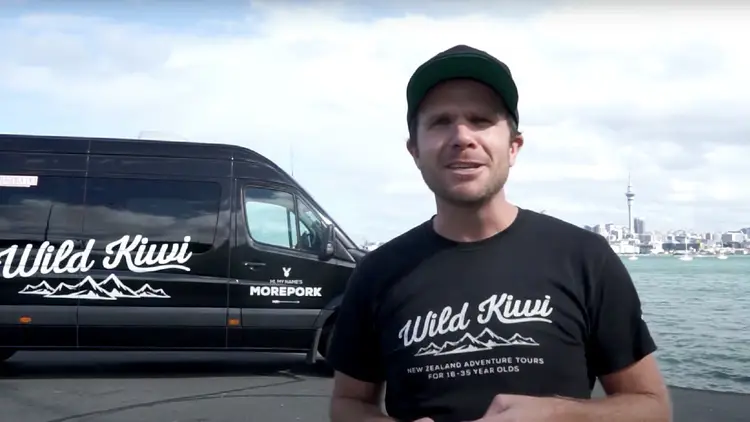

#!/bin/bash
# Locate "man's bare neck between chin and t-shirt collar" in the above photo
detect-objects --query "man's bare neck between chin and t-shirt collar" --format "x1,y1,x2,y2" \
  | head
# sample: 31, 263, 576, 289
433, 192, 519, 242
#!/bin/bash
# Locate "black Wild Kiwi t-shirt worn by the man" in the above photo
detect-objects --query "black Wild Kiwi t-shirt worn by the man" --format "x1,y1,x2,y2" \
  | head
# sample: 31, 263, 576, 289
328, 209, 656, 422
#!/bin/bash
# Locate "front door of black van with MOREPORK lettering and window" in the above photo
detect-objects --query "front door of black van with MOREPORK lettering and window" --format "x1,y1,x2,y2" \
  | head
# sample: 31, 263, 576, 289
229, 180, 337, 350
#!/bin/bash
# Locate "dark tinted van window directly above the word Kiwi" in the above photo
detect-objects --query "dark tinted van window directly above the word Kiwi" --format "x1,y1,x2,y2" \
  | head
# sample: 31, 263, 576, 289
84, 178, 221, 249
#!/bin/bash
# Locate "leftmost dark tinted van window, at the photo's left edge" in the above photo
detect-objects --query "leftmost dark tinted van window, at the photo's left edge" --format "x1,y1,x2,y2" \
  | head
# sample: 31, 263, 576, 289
0, 176, 84, 244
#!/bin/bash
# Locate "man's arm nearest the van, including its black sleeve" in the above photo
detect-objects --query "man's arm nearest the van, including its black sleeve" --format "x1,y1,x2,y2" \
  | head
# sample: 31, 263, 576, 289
326, 258, 395, 422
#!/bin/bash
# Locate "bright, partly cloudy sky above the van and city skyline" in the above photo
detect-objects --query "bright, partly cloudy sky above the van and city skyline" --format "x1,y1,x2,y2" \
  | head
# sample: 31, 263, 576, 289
0, 0, 750, 241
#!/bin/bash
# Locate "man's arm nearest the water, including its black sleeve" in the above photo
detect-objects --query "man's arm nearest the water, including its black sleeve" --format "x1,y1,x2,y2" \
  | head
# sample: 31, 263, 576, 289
560, 242, 672, 422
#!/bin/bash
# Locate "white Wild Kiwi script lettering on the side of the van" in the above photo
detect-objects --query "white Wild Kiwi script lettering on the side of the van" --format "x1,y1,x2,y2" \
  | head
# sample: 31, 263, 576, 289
0, 234, 193, 278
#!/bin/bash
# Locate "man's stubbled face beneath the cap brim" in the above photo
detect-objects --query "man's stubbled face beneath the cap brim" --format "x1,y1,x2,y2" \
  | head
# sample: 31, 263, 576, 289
410, 80, 523, 207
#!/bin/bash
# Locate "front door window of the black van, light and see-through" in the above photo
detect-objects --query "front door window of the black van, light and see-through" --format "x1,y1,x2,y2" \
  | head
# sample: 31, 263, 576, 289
245, 187, 323, 253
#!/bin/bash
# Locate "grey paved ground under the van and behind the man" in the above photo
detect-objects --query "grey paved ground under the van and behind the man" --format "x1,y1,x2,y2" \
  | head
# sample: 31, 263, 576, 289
0, 352, 750, 422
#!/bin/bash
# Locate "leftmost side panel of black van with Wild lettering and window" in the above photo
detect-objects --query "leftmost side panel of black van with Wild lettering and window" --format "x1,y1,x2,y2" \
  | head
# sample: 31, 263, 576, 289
0, 157, 90, 347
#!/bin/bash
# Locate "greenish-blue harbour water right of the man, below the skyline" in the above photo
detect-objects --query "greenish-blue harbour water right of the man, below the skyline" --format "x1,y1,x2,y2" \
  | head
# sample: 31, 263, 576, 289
623, 255, 750, 393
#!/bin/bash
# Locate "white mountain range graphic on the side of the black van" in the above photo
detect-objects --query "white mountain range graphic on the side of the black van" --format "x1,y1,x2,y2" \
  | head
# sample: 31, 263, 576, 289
18, 274, 170, 300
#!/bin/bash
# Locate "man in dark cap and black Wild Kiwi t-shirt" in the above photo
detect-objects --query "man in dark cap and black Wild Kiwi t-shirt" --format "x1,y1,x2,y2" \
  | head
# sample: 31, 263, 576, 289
328, 46, 671, 422
